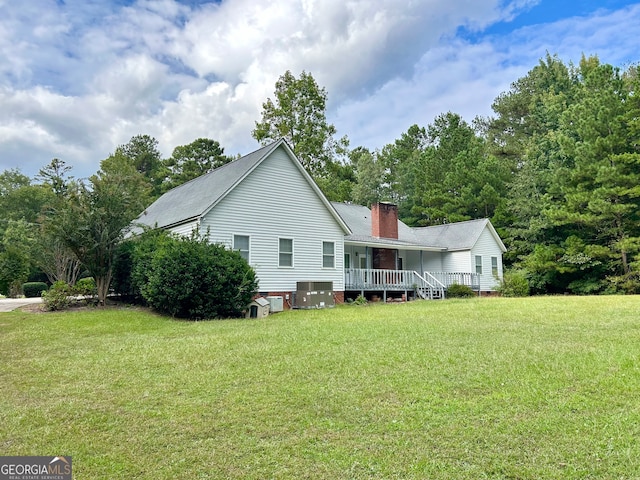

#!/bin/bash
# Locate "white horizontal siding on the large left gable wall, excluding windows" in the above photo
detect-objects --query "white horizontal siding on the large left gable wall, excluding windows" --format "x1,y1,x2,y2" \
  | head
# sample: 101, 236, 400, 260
200, 147, 344, 292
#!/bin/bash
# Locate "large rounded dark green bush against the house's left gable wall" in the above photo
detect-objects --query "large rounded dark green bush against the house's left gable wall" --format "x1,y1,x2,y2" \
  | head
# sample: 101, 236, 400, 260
138, 236, 258, 319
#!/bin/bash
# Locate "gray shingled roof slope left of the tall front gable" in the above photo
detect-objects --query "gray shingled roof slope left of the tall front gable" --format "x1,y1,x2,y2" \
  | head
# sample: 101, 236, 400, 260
134, 141, 282, 228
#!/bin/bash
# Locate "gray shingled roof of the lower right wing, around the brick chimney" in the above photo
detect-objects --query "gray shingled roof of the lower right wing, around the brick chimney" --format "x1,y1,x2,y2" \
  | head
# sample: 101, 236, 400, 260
333, 202, 506, 250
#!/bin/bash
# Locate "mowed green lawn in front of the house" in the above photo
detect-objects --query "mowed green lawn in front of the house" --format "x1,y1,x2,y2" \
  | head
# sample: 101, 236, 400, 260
0, 296, 640, 480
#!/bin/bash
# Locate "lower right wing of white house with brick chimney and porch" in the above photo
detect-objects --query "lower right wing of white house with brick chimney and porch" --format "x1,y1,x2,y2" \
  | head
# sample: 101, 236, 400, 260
333, 203, 506, 298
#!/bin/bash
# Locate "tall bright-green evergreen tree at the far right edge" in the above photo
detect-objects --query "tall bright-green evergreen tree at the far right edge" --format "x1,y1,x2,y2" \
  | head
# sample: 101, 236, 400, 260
546, 57, 640, 293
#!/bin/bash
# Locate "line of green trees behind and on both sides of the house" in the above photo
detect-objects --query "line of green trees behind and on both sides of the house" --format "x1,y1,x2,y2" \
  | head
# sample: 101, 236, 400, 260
0, 55, 640, 300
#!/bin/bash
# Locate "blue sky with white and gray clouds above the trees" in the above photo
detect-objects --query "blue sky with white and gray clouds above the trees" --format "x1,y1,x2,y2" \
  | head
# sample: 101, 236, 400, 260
0, 0, 640, 177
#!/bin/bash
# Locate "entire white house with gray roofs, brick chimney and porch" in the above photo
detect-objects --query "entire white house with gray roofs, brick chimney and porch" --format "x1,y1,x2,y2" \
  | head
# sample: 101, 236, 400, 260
136, 140, 505, 308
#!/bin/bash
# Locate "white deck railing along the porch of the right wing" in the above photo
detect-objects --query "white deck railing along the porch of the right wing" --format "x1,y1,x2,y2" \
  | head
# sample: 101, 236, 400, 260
344, 268, 480, 290
